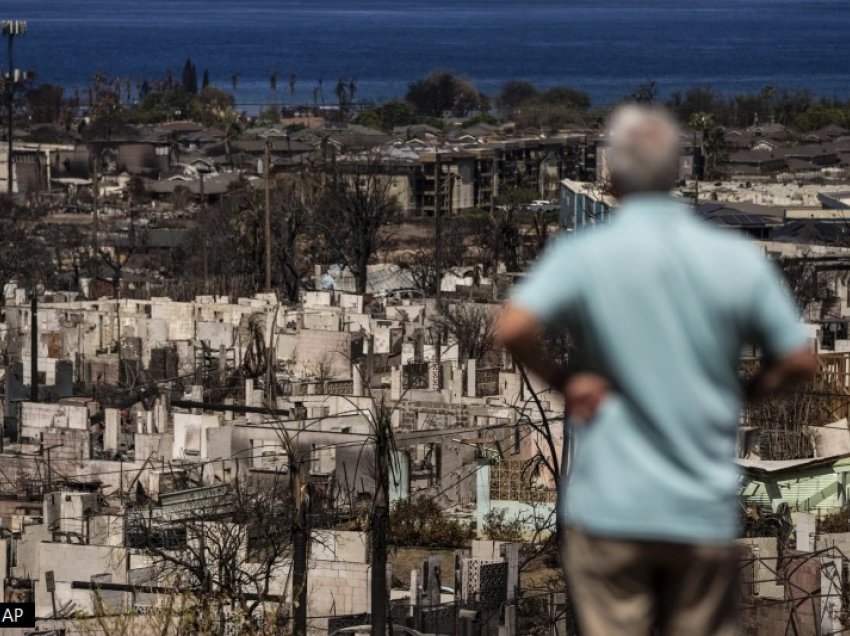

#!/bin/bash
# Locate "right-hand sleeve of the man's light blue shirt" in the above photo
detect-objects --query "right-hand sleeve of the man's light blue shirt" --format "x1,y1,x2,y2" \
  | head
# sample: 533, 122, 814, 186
751, 259, 807, 358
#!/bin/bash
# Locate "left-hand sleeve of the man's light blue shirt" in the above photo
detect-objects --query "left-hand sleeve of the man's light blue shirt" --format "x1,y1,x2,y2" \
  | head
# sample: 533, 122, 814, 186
511, 237, 581, 323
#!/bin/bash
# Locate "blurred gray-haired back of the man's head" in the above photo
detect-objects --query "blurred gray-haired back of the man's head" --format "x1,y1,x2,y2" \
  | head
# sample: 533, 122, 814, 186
608, 104, 681, 197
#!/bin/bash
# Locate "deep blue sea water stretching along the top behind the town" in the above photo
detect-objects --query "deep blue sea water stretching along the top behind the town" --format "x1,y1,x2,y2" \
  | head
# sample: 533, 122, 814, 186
0, 0, 850, 108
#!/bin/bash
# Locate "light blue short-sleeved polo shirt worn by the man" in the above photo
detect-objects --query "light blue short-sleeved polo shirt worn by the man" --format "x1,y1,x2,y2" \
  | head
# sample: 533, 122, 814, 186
506, 195, 806, 543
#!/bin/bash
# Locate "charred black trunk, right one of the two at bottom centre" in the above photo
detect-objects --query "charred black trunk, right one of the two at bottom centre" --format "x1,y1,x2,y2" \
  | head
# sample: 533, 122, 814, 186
370, 415, 390, 636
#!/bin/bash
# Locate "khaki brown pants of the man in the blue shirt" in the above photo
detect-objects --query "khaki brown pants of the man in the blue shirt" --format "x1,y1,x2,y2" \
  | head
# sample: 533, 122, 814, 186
561, 530, 738, 636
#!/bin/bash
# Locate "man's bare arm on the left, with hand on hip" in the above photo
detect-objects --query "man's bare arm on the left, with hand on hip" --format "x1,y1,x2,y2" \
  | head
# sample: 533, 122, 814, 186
495, 304, 611, 422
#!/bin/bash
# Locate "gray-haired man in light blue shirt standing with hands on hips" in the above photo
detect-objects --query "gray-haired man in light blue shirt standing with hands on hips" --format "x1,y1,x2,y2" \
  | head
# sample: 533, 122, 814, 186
497, 105, 816, 636
